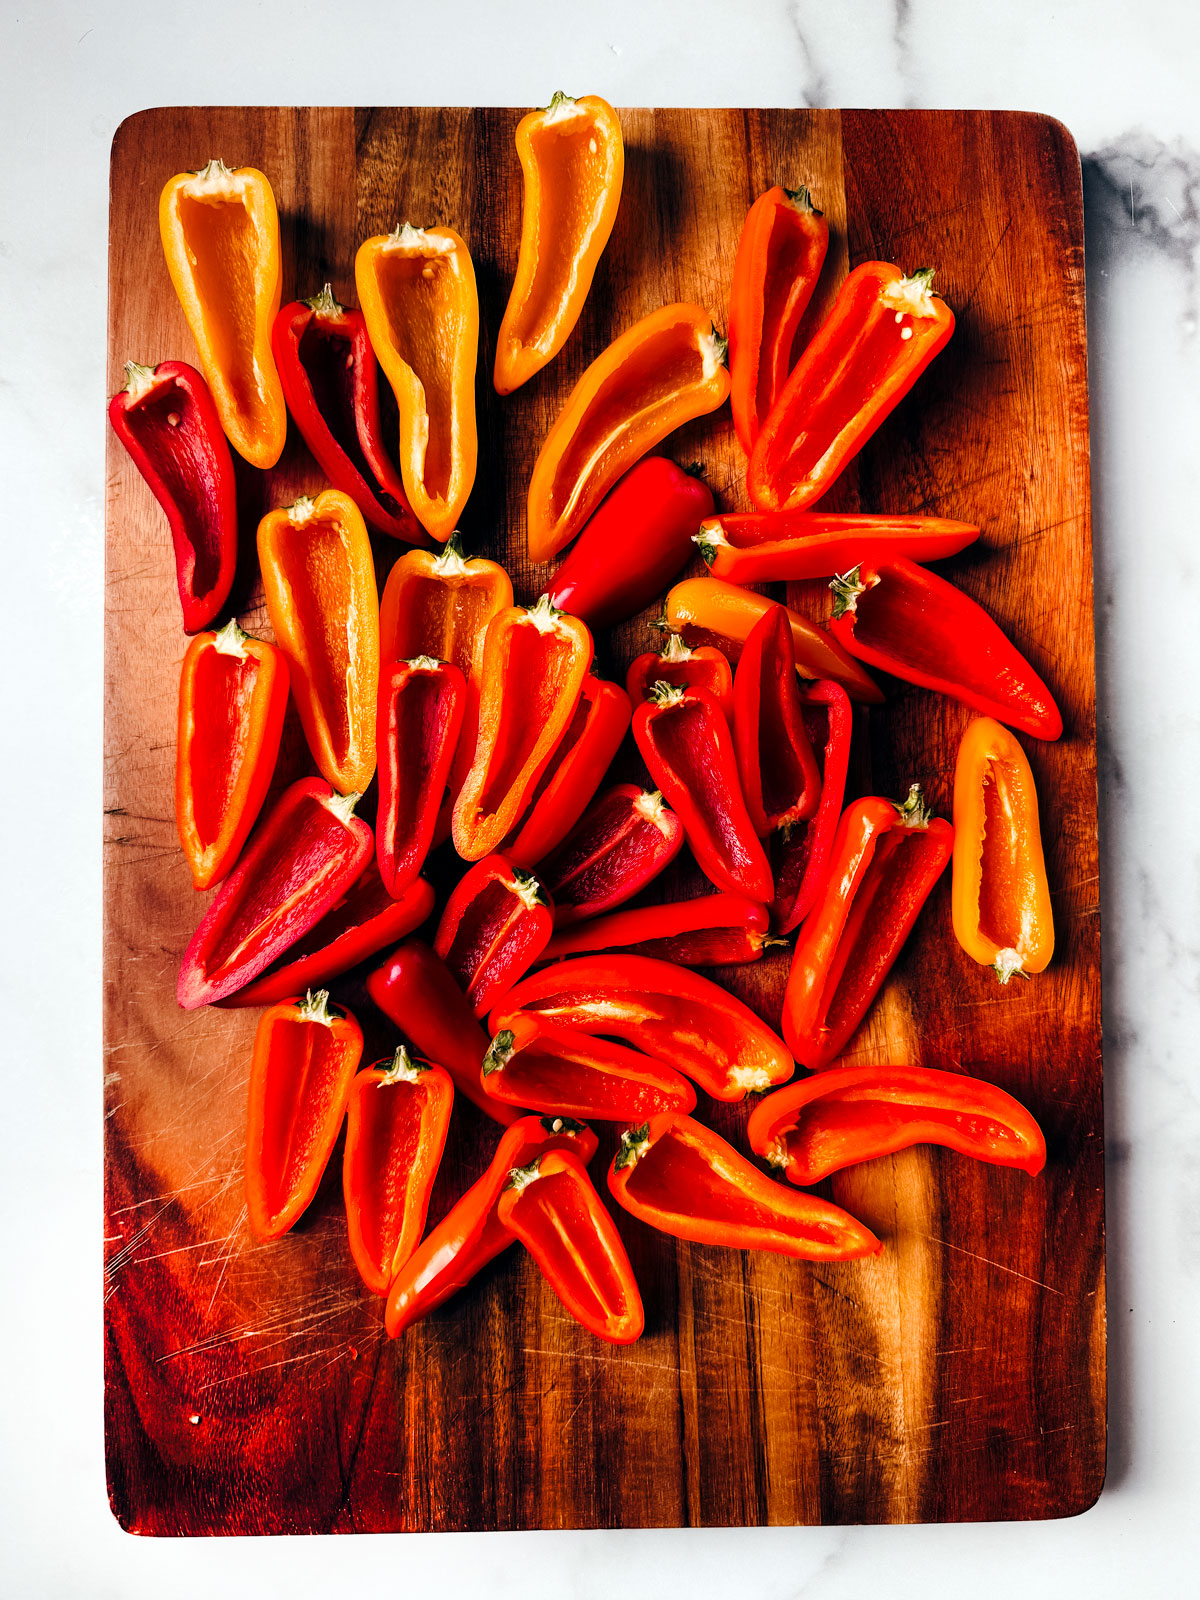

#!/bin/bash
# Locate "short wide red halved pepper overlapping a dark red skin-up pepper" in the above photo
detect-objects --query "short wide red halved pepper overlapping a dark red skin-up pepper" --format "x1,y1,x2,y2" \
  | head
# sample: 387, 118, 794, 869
434, 856, 554, 1016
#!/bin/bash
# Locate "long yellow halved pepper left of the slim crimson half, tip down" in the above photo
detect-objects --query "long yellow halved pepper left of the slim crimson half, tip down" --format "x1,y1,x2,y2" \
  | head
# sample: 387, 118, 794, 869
258, 490, 379, 794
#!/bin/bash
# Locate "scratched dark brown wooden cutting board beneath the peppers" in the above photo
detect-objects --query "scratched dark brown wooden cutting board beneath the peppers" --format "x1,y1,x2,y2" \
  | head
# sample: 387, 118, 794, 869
106, 107, 1104, 1533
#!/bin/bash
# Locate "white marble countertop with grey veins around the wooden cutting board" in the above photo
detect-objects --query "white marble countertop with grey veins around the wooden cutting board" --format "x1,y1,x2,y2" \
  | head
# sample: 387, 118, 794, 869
0, 0, 1200, 1600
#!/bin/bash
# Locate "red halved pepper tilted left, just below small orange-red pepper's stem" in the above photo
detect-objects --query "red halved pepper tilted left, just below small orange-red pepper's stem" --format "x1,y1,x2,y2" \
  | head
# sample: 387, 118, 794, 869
634, 683, 774, 901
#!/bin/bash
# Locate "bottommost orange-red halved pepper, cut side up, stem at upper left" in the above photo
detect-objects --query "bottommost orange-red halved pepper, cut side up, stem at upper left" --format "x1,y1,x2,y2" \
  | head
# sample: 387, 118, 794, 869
496, 1150, 645, 1344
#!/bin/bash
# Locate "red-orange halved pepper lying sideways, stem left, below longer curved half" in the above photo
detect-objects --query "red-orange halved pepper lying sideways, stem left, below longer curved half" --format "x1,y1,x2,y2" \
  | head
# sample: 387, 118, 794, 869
482, 1014, 696, 1122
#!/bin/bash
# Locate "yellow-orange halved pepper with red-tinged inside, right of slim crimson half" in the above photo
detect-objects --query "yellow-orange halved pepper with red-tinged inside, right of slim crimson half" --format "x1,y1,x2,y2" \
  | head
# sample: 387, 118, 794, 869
451, 595, 592, 861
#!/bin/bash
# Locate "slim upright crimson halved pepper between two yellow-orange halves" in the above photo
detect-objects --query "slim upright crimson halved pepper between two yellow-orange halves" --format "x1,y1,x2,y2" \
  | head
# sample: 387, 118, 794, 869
374, 656, 467, 896
